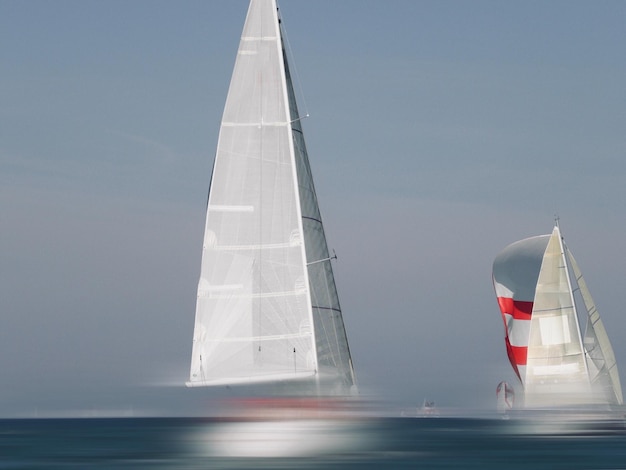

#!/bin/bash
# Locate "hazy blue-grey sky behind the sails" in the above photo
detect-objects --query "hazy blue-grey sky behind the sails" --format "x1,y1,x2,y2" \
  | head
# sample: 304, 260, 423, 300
0, 0, 626, 417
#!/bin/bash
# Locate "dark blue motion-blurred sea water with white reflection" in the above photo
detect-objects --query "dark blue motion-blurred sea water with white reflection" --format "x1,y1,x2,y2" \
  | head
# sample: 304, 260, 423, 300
0, 417, 626, 470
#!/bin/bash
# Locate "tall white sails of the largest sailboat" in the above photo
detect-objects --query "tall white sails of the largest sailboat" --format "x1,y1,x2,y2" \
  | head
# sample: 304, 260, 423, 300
187, 0, 356, 395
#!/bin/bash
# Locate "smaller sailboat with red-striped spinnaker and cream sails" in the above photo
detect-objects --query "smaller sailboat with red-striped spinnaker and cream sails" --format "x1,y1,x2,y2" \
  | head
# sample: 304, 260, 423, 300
493, 221, 623, 409
